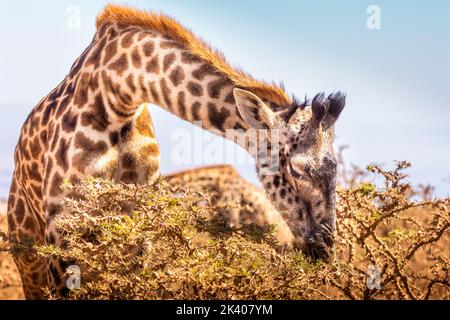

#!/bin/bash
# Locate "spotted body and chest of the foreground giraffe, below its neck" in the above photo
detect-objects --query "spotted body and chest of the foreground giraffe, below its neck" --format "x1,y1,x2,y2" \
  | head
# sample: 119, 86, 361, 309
8, 100, 159, 298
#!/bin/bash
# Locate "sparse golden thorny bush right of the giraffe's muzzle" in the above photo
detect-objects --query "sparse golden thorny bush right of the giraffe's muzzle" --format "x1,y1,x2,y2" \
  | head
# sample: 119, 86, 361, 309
328, 158, 450, 299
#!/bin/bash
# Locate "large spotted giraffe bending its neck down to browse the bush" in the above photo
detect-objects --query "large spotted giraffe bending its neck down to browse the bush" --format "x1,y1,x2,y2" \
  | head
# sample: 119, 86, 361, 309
8, 5, 345, 299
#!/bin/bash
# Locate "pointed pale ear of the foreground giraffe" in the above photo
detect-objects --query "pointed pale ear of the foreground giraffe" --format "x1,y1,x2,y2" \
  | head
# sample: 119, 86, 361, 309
233, 88, 277, 130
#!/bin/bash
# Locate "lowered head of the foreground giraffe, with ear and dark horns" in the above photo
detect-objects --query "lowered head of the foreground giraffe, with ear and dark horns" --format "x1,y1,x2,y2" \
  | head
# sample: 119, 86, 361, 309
234, 89, 345, 261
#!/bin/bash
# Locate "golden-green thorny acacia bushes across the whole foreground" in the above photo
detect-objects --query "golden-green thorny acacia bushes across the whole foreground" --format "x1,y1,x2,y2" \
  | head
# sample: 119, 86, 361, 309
1, 162, 450, 299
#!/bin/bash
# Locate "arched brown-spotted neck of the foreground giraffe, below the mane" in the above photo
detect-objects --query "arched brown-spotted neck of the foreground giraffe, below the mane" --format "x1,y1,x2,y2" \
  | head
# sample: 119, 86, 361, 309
88, 24, 246, 137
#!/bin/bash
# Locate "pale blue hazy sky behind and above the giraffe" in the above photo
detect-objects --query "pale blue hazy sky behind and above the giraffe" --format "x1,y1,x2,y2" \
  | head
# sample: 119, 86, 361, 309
0, 0, 450, 198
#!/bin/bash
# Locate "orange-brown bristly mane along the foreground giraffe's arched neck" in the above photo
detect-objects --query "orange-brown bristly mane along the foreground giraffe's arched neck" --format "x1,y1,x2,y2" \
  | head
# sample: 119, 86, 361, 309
96, 4, 292, 106
